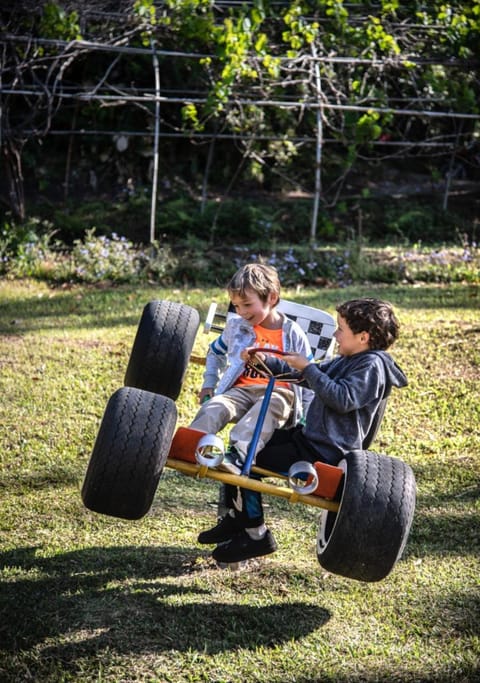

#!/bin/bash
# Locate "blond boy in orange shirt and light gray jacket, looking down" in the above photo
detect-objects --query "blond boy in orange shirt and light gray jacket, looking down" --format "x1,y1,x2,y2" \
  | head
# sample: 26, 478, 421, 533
190, 263, 313, 480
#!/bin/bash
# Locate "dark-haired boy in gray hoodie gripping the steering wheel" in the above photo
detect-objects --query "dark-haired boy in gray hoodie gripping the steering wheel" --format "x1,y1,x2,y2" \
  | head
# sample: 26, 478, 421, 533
200, 298, 407, 563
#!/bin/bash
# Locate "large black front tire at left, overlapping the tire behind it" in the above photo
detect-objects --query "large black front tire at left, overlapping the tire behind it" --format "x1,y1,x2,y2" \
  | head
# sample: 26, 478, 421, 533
82, 387, 177, 519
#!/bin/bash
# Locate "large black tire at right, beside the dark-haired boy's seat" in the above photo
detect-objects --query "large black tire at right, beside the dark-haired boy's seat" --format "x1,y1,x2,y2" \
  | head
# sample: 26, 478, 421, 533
317, 451, 416, 581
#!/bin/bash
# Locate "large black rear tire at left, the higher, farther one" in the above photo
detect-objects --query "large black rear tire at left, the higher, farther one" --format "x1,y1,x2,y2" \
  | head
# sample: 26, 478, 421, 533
125, 301, 200, 401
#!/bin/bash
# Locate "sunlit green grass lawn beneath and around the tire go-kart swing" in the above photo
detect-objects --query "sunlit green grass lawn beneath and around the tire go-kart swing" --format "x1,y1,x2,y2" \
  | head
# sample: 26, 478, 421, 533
0, 281, 480, 683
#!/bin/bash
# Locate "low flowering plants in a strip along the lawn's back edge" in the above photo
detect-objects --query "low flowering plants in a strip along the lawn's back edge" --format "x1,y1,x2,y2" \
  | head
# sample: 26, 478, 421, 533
0, 210, 480, 287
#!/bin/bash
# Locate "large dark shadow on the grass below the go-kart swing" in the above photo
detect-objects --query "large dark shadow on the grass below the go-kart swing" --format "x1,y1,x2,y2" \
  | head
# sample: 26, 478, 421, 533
0, 546, 330, 661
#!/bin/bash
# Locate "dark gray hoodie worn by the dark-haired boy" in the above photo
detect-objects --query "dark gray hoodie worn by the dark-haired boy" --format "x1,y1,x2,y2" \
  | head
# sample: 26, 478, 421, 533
268, 351, 407, 464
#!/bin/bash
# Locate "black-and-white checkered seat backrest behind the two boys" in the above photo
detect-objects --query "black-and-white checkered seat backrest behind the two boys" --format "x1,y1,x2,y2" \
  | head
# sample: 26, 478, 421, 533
204, 299, 336, 360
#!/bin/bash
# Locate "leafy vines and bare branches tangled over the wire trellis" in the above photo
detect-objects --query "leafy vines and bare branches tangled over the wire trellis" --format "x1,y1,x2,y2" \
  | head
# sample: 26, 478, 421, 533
1, 0, 480, 237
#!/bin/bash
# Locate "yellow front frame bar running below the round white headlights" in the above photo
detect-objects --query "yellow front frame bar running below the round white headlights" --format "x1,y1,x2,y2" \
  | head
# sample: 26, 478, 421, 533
166, 458, 340, 512
